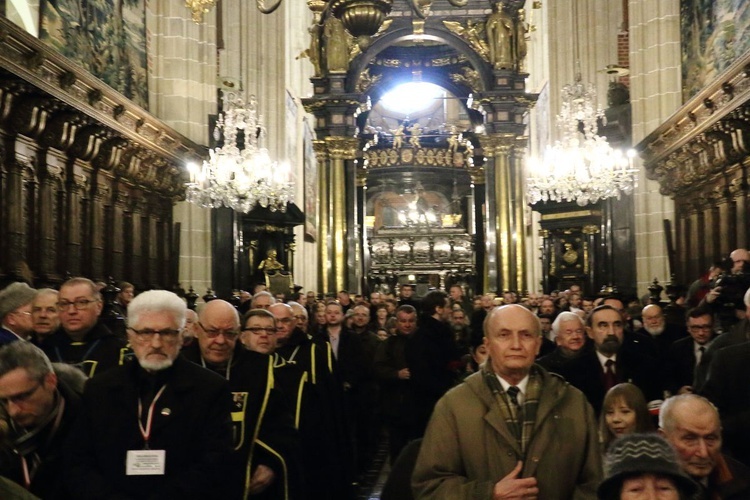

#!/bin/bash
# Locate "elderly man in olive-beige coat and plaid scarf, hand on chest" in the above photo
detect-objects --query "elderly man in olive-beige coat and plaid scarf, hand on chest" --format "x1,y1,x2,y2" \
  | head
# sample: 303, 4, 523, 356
412, 305, 602, 500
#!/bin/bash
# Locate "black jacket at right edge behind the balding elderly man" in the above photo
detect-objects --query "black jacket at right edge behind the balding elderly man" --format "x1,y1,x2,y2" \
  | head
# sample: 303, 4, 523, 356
701, 342, 750, 464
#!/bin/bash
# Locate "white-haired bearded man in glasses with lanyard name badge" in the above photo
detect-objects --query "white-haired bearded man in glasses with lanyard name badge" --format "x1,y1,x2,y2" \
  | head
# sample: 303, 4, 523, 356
65, 290, 239, 499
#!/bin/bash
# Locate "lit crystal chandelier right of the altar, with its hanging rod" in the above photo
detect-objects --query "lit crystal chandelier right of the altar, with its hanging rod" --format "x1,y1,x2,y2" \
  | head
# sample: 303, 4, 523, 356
526, 4, 638, 206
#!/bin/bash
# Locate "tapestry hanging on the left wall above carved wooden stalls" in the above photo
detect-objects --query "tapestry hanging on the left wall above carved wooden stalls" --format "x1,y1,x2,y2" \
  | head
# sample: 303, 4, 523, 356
39, 0, 148, 109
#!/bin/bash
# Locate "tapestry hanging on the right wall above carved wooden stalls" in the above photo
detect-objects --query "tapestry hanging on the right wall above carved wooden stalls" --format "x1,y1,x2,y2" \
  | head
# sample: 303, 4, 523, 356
680, 0, 750, 101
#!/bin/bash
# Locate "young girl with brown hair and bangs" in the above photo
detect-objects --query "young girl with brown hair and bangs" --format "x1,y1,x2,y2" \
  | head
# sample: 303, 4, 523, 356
599, 383, 654, 451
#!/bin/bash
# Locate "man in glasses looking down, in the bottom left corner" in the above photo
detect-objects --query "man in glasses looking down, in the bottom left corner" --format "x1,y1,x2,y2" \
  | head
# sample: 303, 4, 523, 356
0, 342, 85, 500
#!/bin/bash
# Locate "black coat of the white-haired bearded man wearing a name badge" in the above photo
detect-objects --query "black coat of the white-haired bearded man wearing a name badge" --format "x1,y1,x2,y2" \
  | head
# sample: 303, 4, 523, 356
65, 356, 239, 500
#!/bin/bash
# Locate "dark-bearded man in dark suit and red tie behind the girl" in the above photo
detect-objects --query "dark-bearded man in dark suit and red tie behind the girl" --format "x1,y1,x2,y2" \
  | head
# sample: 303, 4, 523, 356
565, 305, 661, 414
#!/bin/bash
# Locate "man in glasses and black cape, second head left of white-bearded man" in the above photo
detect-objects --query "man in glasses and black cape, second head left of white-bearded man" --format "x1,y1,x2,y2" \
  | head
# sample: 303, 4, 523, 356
41, 277, 130, 377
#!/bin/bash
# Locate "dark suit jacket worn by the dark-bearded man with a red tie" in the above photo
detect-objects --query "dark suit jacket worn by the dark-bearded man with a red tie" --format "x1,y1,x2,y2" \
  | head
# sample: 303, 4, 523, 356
562, 345, 661, 415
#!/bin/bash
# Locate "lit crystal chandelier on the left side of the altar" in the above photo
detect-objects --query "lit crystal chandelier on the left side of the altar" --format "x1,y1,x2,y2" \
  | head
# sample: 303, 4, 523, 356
186, 91, 294, 213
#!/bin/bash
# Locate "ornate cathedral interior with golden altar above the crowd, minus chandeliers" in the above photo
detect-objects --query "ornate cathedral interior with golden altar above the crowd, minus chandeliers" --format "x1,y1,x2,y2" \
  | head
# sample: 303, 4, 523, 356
0, 0, 750, 296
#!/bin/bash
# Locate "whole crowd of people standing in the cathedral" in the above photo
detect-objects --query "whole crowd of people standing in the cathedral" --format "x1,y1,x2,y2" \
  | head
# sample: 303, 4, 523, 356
0, 249, 750, 500
